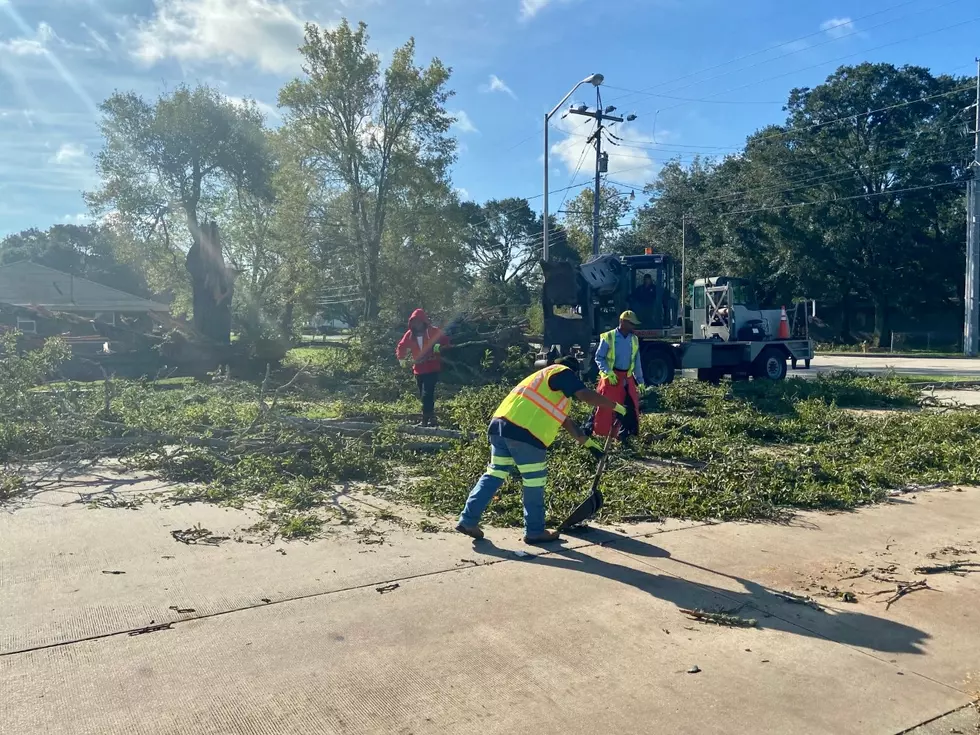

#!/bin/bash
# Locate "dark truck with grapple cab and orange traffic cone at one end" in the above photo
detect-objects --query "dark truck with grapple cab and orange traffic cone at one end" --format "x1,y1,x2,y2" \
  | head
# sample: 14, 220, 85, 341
537, 249, 815, 385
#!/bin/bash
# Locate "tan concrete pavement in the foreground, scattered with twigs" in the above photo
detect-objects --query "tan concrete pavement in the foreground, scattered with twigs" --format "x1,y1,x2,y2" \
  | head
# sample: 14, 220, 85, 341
0, 486, 980, 735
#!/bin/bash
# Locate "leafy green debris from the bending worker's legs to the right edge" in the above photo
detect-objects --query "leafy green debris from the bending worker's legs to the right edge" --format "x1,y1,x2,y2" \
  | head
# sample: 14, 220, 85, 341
406, 375, 980, 525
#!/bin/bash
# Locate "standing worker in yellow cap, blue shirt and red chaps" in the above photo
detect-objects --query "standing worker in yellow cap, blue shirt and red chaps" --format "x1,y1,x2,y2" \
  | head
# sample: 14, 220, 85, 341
592, 311, 643, 440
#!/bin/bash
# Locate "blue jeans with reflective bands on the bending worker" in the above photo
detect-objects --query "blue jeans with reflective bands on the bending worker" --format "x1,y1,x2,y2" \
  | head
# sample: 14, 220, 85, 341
459, 435, 548, 535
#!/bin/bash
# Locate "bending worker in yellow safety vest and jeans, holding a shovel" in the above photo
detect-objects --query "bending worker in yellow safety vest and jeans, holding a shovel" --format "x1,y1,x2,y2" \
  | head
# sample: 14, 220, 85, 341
456, 356, 626, 544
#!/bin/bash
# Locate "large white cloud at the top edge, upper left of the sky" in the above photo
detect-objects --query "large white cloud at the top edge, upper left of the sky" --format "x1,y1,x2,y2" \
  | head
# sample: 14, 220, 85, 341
132, 0, 303, 73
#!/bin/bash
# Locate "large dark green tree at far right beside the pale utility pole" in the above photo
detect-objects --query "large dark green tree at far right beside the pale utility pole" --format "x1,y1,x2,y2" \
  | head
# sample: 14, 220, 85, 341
776, 63, 969, 344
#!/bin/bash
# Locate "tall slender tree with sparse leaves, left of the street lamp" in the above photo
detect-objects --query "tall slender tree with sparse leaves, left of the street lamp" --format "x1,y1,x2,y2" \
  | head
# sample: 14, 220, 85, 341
279, 20, 455, 319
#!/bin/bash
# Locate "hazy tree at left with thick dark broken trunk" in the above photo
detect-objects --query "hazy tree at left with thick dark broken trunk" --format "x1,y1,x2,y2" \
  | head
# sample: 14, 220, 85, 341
86, 86, 271, 341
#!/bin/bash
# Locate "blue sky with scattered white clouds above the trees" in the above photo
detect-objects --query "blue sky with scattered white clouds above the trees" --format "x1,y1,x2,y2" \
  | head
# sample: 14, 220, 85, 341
0, 0, 980, 236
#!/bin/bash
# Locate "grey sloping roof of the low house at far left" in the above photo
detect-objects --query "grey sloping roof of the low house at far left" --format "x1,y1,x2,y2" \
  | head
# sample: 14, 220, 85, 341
0, 260, 170, 312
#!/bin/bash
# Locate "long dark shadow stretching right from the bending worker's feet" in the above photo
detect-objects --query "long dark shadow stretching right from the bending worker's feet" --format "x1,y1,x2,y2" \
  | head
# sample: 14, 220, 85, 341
473, 529, 930, 654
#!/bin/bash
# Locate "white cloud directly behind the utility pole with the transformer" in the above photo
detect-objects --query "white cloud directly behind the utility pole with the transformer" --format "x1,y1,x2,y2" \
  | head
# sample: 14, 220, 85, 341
551, 115, 658, 186
